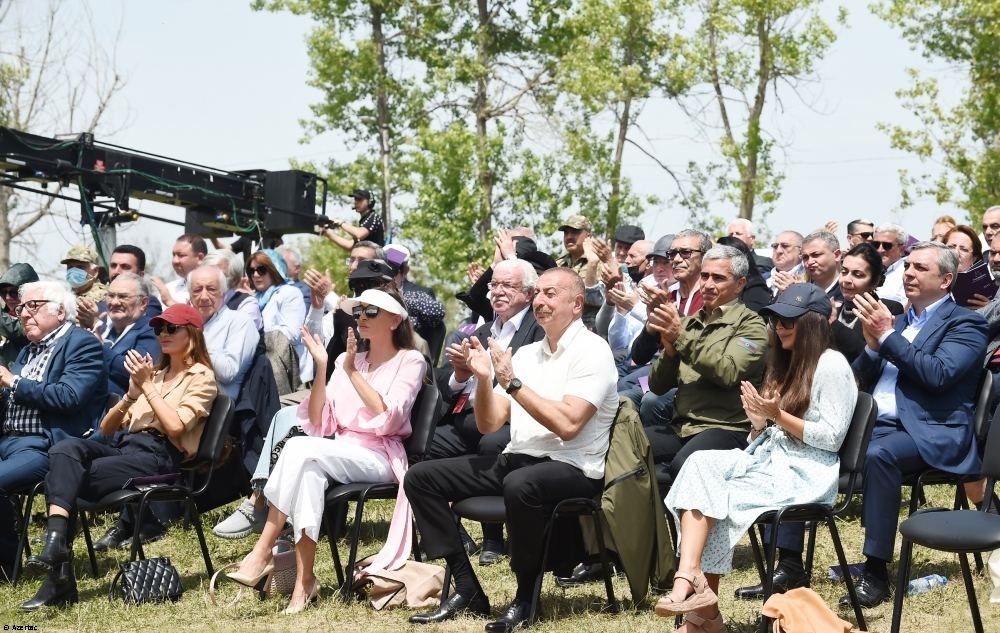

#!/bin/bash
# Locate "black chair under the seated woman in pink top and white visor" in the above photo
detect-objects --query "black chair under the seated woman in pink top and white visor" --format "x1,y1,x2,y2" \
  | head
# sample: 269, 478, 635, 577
323, 374, 440, 599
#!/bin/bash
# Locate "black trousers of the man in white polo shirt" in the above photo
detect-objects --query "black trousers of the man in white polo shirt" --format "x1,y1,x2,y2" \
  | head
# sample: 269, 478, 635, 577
403, 453, 603, 577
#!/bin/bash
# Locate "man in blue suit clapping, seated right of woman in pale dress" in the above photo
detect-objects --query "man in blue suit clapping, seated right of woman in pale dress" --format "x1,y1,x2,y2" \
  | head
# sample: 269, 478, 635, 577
841, 242, 987, 607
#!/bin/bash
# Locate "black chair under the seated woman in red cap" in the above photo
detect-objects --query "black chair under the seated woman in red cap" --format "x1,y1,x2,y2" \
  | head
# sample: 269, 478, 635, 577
77, 393, 233, 577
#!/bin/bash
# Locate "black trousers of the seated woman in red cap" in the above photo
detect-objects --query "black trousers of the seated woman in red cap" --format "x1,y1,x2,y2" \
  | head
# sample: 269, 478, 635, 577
45, 433, 181, 512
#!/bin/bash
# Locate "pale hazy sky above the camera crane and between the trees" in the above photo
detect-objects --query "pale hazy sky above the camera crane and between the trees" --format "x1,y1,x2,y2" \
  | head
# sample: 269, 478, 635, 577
5, 0, 967, 273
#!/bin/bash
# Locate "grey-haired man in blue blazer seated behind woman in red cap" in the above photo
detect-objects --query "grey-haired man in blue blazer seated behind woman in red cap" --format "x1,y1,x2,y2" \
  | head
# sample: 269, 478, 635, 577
98, 273, 160, 396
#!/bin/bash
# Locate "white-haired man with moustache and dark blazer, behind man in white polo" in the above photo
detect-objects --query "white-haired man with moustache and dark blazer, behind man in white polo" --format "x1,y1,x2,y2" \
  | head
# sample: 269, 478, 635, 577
427, 259, 545, 565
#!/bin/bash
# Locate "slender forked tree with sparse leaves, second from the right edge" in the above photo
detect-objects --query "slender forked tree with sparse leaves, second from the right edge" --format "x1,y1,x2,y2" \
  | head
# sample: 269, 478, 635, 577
677, 0, 846, 226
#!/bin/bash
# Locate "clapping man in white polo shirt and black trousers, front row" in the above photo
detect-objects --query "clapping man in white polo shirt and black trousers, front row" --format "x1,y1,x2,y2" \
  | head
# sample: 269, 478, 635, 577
403, 268, 618, 633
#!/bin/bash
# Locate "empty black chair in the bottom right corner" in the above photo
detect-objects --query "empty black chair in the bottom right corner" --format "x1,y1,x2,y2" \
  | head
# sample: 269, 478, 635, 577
891, 404, 1000, 633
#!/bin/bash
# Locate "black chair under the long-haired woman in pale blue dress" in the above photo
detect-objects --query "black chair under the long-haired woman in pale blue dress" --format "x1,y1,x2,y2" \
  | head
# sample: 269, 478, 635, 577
750, 393, 878, 633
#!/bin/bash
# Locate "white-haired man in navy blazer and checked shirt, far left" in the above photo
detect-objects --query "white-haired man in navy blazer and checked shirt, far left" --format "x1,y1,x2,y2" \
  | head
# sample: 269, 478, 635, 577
0, 281, 108, 584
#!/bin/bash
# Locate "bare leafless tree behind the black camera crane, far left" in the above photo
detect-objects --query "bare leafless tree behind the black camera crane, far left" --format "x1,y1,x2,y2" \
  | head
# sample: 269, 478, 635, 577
0, 1, 125, 270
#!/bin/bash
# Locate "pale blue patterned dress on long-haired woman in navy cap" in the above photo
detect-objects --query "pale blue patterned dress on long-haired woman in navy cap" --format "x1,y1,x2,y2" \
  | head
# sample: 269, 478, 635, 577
664, 350, 858, 574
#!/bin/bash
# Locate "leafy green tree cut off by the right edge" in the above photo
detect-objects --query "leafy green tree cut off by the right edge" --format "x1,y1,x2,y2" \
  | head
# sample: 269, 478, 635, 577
875, 0, 1000, 222
